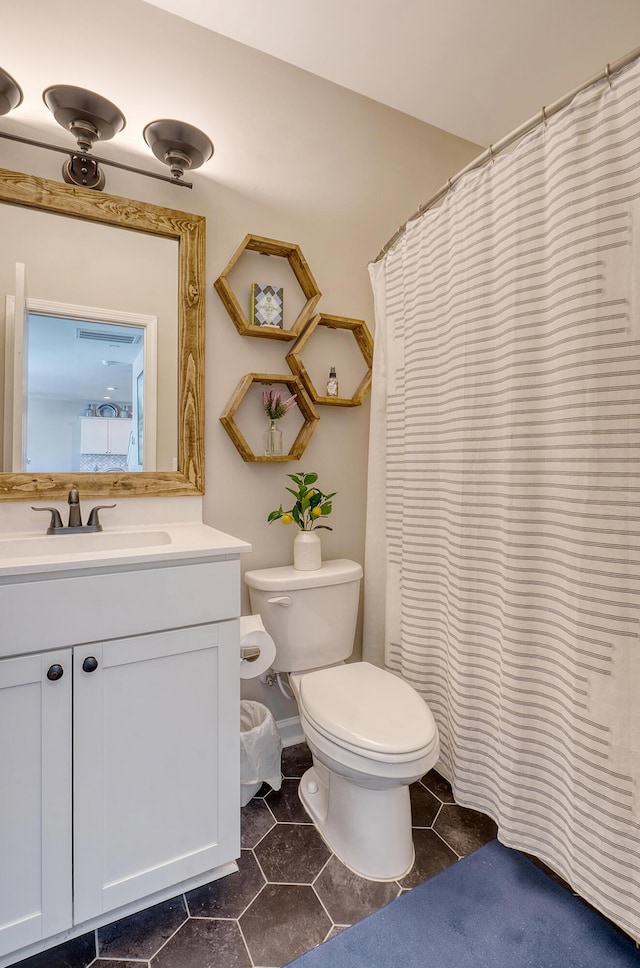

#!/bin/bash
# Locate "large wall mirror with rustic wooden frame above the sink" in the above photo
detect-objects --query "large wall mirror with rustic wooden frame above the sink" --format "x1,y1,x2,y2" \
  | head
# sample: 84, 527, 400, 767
0, 169, 205, 500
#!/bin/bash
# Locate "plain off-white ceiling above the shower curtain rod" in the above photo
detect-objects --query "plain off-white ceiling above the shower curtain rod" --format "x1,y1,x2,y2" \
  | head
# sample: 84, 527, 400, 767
146, 0, 640, 146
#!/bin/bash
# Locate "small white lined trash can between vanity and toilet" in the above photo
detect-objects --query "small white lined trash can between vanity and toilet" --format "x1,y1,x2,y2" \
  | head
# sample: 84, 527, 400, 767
240, 699, 282, 807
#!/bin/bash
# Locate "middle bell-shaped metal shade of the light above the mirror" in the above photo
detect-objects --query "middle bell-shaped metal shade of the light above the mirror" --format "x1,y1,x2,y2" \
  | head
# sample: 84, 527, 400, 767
42, 84, 126, 151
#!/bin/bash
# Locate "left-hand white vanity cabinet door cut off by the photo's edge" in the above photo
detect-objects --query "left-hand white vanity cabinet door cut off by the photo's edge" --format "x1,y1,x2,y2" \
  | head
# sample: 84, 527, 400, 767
0, 649, 72, 956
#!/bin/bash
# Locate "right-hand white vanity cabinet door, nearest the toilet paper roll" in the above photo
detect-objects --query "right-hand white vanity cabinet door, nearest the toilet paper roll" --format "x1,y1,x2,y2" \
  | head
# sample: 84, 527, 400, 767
74, 621, 240, 924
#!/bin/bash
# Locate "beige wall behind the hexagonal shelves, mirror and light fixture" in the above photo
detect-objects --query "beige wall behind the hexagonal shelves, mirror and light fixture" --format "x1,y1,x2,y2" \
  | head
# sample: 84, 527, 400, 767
0, 0, 479, 712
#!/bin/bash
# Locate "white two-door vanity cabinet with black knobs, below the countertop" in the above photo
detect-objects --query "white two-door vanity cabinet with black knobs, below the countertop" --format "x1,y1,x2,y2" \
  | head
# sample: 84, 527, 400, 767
0, 538, 246, 968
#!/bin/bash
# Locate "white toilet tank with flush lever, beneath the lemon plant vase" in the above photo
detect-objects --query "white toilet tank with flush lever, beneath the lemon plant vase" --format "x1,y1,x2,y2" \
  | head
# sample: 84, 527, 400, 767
244, 558, 362, 672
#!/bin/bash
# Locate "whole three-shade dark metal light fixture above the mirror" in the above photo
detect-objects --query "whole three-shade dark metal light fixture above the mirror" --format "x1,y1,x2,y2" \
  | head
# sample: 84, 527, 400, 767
0, 68, 213, 191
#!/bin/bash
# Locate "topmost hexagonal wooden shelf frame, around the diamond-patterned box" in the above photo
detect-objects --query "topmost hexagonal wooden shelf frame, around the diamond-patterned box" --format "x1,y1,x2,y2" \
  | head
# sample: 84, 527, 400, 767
214, 235, 322, 340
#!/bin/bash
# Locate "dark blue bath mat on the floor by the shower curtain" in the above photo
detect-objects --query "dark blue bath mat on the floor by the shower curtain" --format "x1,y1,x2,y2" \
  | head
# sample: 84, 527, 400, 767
291, 840, 640, 968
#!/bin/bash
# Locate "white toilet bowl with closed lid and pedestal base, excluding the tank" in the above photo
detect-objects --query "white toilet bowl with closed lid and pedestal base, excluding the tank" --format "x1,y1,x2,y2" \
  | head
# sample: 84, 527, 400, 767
290, 662, 438, 880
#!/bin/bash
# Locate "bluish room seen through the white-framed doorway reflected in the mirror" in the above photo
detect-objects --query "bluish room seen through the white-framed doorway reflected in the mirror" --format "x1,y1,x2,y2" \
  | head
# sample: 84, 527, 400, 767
15, 307, 156, 473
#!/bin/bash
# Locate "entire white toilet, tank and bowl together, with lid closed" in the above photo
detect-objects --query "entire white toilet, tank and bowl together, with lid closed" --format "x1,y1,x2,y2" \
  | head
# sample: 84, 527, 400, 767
244, 559, 439, 881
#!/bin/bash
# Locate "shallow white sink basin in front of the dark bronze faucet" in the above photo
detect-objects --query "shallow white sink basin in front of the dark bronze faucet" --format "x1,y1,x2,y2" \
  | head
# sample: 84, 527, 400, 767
0, 531, 171, 561
